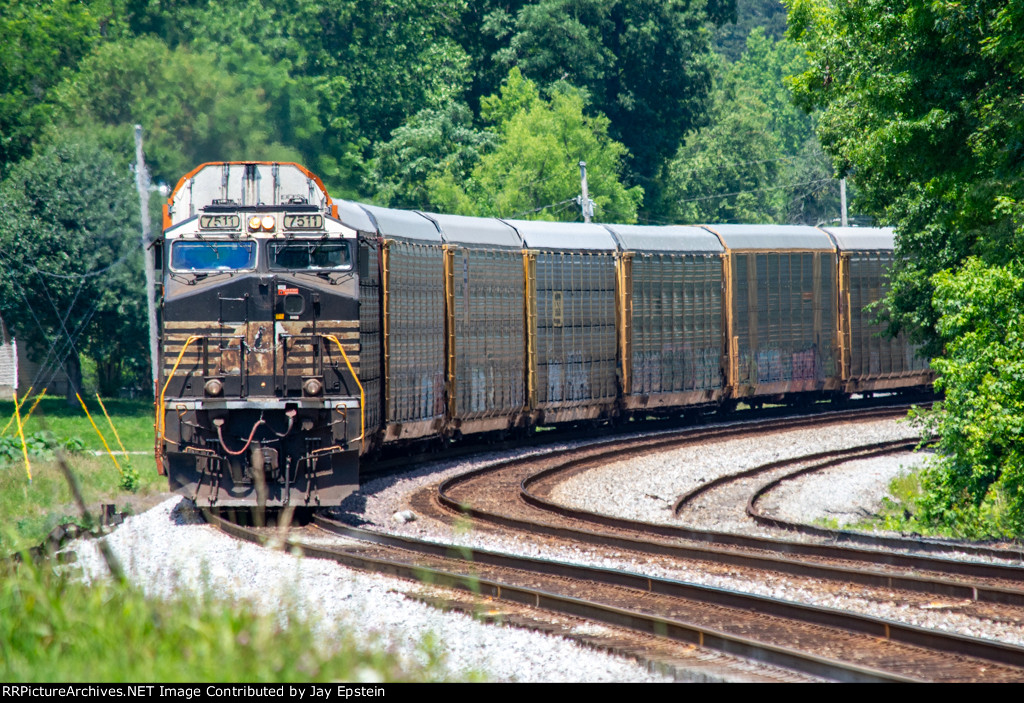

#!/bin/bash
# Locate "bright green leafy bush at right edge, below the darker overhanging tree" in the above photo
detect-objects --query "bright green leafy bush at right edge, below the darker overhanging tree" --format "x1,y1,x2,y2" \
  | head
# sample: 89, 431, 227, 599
923, 258, 1024, 536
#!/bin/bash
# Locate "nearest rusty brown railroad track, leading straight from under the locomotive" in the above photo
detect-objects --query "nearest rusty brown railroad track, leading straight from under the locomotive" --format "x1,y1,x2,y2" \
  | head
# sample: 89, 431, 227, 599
208, 515, 1024, 682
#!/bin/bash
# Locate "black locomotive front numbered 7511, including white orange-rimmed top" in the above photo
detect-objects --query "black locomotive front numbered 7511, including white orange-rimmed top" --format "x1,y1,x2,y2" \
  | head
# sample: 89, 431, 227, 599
157, 163, 365, 507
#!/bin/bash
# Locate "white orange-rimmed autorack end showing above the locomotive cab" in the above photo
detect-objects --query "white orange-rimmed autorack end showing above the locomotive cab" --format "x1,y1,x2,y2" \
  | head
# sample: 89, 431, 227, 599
164, 162, 332, 229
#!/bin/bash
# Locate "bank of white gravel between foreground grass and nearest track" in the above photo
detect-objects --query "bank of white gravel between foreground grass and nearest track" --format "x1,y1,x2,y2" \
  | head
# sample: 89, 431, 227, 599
73, 497, 670, 683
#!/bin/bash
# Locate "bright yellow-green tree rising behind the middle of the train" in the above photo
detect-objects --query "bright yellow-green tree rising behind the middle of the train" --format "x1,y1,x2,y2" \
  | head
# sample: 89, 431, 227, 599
427, 69, 643, 222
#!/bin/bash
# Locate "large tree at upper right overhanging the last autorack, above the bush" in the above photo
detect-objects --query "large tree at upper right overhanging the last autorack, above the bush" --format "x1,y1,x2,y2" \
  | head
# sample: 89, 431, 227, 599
790, 0, 1024, 355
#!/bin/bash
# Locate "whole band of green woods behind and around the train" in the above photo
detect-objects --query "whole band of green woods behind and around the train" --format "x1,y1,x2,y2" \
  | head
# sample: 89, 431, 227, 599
0, 0, 1024, 533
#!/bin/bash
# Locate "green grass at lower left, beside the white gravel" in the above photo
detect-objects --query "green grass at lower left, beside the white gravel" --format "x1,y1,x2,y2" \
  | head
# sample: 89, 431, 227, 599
0, 398, 478, 684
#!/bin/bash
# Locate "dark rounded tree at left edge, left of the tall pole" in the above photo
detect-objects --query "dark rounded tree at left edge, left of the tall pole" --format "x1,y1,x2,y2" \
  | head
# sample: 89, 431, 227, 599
0, 137, 148, 403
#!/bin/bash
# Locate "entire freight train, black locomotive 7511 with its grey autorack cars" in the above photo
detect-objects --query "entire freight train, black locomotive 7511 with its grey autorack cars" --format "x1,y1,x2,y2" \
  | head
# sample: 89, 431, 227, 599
153, 162, 934, 508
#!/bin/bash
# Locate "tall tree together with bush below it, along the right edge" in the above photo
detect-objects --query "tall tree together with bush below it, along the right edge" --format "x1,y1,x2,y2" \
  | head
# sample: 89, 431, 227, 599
790, 0, 1024, 535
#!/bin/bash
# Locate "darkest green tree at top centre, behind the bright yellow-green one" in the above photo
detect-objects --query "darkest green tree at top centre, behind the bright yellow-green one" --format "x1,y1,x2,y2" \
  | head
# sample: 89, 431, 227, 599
484, 0, 735, 192
